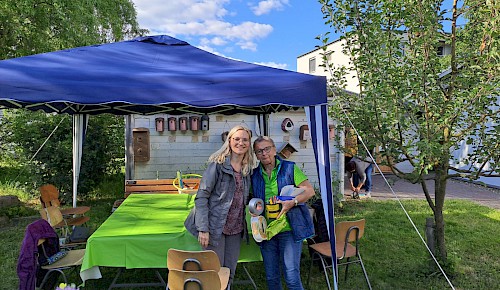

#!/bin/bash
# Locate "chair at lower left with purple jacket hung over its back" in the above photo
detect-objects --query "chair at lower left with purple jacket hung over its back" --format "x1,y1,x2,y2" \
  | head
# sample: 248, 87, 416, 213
37, 239, 85, 289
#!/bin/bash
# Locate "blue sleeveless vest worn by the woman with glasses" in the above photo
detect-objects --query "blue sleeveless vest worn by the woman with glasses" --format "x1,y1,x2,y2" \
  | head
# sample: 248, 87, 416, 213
252, 156, 314, 242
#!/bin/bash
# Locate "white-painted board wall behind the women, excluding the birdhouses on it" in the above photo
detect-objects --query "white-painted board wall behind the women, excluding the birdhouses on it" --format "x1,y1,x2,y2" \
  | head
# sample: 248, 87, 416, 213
133, 110, 335, 186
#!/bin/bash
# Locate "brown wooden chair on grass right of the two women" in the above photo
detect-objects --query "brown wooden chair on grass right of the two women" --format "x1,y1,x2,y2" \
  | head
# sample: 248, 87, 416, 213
307, 219, 372, 290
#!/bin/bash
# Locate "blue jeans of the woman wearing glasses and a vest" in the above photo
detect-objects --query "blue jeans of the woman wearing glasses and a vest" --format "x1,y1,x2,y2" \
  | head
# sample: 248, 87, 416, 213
260, 231, 304, 290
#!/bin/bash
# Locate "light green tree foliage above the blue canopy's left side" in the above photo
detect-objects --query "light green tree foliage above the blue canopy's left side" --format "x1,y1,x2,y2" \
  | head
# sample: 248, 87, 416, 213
0, 0, 145, 59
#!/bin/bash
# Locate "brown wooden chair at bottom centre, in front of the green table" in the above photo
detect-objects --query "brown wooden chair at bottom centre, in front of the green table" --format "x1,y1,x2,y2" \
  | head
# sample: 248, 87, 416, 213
167, 249, 230, 290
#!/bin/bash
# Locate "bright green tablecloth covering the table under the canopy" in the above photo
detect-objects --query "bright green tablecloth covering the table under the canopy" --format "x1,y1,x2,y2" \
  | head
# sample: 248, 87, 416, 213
81, 194, 262, 272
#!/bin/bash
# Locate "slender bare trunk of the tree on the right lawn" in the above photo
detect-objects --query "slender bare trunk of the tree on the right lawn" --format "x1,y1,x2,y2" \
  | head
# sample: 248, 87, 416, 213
434, 163, 448, 263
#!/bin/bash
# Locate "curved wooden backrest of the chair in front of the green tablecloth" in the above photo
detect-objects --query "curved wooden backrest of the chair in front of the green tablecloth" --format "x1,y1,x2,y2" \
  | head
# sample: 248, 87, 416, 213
167, 248, 221, 272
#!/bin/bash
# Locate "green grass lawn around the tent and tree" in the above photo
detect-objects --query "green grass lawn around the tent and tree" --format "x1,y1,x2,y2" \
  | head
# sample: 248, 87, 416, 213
0, 169, 500, 289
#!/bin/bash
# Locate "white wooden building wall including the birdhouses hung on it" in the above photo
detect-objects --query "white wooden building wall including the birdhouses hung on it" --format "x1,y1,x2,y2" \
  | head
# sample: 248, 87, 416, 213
127, 109, 336, 187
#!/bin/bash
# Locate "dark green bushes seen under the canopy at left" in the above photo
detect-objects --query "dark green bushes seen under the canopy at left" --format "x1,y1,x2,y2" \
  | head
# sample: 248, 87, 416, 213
0, 110, 125, 195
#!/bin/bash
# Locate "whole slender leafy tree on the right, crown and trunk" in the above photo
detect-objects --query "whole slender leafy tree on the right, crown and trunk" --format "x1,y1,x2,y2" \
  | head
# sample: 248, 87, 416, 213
319, 0, 500, 260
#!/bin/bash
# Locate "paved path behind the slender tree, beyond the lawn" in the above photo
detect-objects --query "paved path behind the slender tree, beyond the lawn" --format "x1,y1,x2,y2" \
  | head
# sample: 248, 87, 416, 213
344, 174, 500, 210
